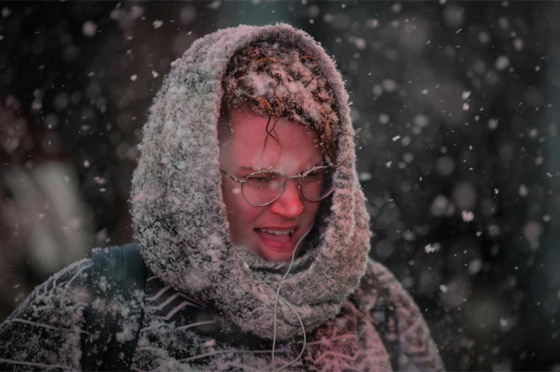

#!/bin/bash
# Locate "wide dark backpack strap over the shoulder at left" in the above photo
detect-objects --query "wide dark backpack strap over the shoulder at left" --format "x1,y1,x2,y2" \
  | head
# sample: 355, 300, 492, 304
81, 243, 146, 371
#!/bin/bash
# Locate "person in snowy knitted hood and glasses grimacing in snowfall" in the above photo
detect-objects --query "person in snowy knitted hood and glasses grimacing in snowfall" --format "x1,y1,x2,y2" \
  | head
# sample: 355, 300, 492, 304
0, 24, 444, 371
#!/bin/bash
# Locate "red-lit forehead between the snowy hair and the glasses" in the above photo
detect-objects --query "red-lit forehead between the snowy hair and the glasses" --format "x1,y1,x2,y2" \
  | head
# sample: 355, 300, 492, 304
220, 109, 322, 173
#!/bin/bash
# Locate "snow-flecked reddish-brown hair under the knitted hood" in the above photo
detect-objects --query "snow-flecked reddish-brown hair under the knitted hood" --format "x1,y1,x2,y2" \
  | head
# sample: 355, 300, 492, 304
220, 41, 340, 164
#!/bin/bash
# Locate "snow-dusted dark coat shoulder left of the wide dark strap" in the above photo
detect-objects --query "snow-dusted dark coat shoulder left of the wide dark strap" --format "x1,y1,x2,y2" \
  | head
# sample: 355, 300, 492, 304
0, 259, 92, 370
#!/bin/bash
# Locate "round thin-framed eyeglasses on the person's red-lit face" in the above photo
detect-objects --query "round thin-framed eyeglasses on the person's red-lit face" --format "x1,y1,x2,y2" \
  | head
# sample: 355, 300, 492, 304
220, 165, 334, 207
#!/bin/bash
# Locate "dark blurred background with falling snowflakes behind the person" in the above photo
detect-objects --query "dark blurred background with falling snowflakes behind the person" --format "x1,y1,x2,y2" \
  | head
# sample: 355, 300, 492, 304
0, 0, 560, 371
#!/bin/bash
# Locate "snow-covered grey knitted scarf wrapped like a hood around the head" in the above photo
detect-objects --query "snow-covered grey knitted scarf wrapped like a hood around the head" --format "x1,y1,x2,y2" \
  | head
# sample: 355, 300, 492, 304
131, 24, 369, 339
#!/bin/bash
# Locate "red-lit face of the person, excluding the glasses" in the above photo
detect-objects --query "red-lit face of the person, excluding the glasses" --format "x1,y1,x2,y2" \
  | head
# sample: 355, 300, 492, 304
220, 107, 323, 262
